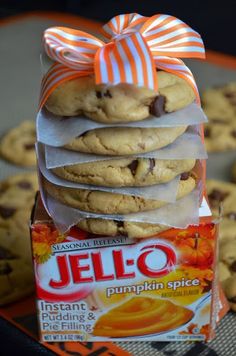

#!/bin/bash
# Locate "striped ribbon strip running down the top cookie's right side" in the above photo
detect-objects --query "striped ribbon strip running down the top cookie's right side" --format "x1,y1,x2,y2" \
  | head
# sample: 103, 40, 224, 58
154, 56, 201, 105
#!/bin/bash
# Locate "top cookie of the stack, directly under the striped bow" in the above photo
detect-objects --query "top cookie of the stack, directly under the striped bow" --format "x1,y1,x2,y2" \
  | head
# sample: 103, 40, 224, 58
45, 71, 195, 123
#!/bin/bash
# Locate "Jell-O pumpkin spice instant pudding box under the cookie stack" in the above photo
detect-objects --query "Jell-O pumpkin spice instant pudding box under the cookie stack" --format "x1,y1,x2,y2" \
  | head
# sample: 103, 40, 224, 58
31, 196, 221, 342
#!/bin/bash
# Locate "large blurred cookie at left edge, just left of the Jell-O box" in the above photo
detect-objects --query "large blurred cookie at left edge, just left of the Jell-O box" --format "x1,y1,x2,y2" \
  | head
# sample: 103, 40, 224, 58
0, 172, 38, 305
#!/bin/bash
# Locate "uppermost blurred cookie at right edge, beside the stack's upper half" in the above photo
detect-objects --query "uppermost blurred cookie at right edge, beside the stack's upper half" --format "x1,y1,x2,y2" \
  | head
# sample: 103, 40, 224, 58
202, 83, 236, 152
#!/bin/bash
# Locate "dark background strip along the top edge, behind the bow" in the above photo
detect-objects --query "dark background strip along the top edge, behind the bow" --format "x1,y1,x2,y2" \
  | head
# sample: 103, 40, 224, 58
0, 0, 236, 55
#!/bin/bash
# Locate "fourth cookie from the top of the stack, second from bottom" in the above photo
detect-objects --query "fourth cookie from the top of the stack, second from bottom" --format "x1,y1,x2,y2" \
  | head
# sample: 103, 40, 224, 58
44, 175, 196, 214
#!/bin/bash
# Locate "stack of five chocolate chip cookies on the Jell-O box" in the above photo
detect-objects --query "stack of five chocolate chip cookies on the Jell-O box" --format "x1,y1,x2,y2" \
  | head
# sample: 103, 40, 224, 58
35, 71, 206, 238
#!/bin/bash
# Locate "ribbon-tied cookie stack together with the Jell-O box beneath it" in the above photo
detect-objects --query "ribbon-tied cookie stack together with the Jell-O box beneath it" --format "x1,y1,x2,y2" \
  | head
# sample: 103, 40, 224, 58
31, 14, 227, 342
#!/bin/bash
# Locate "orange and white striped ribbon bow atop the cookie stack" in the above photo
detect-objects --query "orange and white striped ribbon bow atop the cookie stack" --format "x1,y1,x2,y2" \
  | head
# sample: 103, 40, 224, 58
40, 13, 205, 107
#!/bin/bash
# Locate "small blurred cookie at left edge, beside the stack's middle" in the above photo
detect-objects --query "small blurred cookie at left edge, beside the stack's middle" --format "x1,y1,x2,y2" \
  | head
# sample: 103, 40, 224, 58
0, 121, 36, 166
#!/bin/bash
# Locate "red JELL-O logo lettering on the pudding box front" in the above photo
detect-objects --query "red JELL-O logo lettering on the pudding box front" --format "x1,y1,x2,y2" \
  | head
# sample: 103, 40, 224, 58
49, 240, 177, 289
